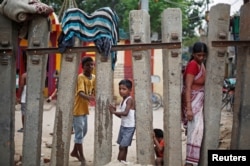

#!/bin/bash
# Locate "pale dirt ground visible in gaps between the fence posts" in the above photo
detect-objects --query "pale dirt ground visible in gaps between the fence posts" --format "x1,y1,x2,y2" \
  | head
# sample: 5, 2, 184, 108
15, 101, 232, 166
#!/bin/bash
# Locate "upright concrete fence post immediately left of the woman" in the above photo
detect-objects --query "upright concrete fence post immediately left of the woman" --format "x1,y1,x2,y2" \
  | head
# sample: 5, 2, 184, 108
162, 8, 182, 165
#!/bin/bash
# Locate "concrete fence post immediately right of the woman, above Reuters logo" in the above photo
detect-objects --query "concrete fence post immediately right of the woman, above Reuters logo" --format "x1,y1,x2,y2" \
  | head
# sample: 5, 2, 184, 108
200, 4, 230, 166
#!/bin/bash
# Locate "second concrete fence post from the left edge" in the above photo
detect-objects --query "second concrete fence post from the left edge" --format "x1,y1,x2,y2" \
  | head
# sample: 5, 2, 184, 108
22, 16, 49, 165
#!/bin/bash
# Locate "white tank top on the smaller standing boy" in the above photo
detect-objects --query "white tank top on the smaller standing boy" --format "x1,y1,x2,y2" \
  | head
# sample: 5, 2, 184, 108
120, 96, 135, 127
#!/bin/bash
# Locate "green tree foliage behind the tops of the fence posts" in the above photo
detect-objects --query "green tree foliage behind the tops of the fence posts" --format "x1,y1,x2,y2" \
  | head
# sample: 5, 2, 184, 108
42, 0, 209, 45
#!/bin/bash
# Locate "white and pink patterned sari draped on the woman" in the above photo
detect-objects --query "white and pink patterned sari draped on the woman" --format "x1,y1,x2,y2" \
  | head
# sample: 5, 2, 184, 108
182, 65, 205, 165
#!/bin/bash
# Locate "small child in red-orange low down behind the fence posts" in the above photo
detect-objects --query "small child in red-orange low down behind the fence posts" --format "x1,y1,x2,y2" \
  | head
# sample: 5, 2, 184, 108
153, 129, 165, 166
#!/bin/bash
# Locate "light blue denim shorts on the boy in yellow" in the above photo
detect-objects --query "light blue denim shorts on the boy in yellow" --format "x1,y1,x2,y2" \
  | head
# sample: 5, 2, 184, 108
73, 115, 88, 144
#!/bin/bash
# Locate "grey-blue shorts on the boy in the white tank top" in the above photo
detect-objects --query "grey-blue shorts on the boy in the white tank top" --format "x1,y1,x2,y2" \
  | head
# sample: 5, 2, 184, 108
117, 126, 135, 147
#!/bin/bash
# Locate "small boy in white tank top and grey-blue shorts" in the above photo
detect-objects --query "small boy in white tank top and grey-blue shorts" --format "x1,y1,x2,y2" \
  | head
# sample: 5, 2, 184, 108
109, 79, 135, 164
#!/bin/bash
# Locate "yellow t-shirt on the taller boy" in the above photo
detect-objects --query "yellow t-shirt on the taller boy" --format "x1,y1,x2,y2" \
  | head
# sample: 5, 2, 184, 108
73, 73, 95, 116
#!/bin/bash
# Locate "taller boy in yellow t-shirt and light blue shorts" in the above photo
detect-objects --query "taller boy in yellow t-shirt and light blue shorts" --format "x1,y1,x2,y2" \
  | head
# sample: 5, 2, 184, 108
70, 57, 95, 165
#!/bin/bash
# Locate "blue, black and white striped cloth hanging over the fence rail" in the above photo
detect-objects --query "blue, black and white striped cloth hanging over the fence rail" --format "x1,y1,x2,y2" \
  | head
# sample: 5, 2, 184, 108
58, 7, 119, 68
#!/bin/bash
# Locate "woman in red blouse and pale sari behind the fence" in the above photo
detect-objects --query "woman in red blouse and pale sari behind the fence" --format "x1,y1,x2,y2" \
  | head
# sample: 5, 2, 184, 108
182, 42, 208, 166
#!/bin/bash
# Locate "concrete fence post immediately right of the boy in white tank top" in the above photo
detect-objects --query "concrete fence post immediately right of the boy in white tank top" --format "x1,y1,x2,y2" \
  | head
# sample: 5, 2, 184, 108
129, 10, 154, 165
